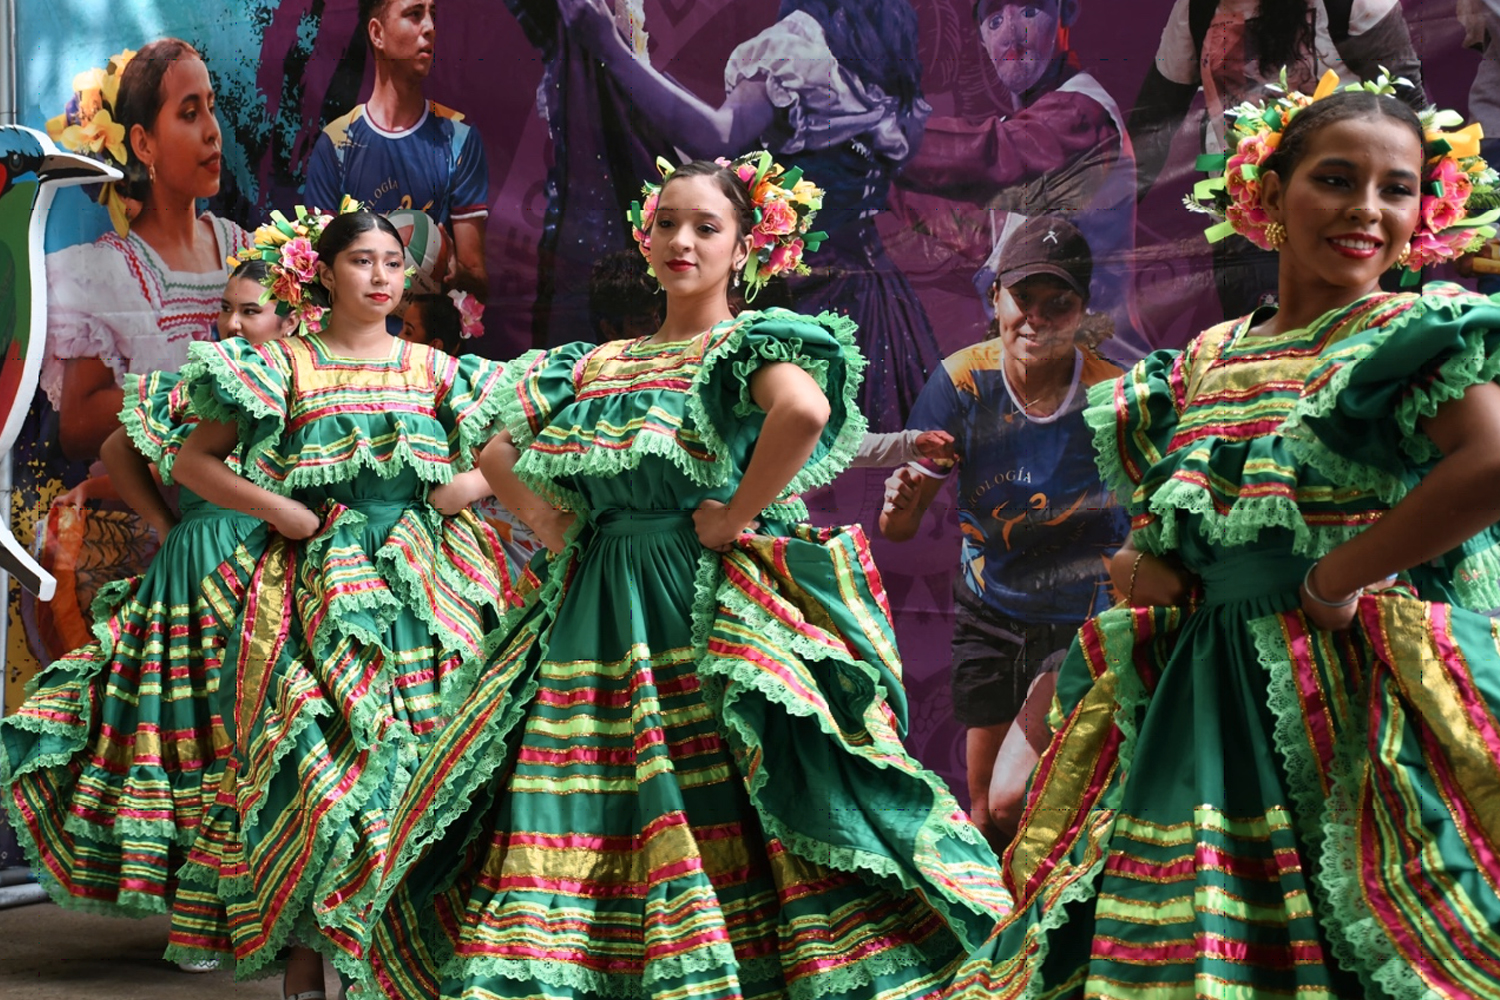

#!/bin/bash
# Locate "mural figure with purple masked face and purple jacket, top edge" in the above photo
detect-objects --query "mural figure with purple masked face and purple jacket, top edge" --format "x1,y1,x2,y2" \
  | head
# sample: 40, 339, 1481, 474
897, 0, 1151, 360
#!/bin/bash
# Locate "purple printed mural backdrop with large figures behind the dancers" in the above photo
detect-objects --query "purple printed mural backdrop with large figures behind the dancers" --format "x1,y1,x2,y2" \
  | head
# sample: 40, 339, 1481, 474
5, 0, 1482, 795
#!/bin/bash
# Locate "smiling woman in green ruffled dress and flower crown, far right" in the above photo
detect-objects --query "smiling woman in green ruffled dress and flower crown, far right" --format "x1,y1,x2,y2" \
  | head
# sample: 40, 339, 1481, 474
954, 81, 1500, 1000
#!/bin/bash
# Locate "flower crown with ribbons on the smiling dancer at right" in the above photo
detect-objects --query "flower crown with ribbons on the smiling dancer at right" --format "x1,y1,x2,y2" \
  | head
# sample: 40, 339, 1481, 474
1184, 69, 1500, 285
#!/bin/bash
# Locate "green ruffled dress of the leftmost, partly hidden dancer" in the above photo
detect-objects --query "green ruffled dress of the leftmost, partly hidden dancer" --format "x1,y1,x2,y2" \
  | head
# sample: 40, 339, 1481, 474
0, 364, 264, 958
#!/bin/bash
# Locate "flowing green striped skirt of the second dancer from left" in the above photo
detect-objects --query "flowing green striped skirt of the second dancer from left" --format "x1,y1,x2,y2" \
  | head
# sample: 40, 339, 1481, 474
180, 499, 513, 978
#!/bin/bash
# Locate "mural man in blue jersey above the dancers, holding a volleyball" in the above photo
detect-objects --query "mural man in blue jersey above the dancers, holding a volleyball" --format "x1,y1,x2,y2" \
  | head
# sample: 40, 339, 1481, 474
303, 0, 489, 301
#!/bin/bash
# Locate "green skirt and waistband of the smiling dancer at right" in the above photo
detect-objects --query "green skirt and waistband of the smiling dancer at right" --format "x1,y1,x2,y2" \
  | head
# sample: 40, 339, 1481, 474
954, 550, 1500, 1000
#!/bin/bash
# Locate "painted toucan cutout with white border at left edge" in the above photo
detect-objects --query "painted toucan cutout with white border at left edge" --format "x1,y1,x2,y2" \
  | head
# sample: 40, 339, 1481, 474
0, 124, 120, 601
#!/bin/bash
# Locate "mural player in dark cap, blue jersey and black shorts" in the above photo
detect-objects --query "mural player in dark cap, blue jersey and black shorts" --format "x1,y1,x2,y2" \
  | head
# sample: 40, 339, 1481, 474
881, 216, 1128, 847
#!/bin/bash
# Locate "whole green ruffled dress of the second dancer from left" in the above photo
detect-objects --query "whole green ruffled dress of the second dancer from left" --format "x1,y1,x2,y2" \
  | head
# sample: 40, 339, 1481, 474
170, 334, 513, 976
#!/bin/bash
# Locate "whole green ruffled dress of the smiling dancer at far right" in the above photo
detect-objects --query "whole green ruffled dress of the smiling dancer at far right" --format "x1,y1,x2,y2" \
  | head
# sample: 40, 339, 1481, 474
954, 283, 1500, 1000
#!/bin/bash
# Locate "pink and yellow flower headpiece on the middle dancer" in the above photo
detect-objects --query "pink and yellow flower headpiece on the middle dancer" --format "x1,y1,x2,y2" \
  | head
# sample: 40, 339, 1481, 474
630, 150, 828, 301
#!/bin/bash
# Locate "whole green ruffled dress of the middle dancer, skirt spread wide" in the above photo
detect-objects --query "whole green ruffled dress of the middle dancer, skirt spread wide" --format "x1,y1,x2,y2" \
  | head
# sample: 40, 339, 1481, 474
354, 309, 1008, 1000
